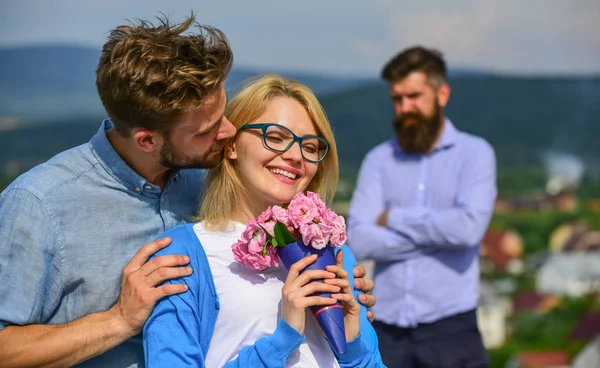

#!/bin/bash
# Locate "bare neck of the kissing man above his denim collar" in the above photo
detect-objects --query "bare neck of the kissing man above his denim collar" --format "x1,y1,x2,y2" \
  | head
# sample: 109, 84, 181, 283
106, 128, 170, 189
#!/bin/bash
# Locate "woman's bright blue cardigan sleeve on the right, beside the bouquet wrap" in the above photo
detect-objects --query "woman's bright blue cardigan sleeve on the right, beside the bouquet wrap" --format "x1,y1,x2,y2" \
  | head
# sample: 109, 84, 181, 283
334, 245, 385, 368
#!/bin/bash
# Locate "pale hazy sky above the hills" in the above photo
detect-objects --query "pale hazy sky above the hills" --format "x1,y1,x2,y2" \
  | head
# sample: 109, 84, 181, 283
0, 0, 600, 77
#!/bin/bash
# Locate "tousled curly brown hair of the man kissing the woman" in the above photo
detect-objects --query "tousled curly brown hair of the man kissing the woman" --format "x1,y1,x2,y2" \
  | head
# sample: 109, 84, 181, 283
96, 14, 233, 137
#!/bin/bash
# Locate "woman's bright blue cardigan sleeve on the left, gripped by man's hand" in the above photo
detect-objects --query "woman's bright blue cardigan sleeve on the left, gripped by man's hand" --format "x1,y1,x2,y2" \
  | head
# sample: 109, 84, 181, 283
143, 229, 305, 368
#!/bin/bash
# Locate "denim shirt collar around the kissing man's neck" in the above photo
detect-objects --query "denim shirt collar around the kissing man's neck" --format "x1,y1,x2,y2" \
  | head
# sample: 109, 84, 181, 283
90, 119, 173, 195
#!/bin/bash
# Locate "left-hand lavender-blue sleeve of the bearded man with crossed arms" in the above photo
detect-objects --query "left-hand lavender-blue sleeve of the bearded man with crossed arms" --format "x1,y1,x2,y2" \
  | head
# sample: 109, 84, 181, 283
348, 151, 421, 262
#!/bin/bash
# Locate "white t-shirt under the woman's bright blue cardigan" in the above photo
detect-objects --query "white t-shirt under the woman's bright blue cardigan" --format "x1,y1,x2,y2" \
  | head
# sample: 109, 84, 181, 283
194, 222, 339, 368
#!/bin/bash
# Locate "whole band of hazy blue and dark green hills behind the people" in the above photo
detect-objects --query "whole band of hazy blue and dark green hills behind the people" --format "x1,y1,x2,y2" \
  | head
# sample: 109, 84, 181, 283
0, 46, 600, 181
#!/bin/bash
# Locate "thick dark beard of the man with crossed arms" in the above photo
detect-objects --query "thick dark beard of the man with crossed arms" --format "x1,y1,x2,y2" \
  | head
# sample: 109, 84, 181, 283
394, 102, 443, 154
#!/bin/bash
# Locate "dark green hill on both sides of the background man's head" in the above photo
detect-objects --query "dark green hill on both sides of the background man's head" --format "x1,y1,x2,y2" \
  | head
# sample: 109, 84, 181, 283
321, 76, 600, 175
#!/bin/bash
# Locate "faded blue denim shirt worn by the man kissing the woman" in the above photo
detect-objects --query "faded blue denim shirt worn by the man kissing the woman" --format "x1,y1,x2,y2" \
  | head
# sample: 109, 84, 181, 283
0, 120, 204, 367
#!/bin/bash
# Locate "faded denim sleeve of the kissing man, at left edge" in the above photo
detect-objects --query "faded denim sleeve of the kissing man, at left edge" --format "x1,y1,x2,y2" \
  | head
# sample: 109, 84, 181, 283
0, 189, 64, 329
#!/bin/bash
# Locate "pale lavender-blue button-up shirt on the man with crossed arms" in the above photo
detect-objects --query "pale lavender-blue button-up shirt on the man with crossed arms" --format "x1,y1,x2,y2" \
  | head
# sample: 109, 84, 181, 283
348, 119, 496, 327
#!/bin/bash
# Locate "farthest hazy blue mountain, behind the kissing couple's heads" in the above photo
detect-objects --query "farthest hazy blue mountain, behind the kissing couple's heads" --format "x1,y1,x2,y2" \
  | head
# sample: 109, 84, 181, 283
0, 45, 366, 120
